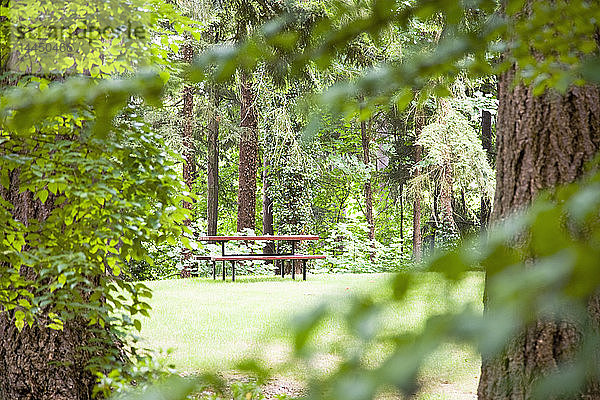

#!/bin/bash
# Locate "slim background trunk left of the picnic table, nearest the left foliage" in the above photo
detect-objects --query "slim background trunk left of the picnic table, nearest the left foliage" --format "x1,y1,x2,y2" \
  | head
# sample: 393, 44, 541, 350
181, 37, 196, 278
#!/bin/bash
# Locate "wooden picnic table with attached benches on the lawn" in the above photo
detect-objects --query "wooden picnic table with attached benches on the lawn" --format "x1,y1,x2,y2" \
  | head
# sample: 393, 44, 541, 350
196, 235, 325, 281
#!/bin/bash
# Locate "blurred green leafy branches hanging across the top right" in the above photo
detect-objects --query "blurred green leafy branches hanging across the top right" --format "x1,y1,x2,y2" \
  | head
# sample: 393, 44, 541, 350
191, 0, 600, 116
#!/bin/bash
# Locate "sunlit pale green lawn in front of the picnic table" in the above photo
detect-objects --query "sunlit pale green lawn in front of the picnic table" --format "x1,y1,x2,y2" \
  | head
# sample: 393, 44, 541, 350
141, 273, 483, 400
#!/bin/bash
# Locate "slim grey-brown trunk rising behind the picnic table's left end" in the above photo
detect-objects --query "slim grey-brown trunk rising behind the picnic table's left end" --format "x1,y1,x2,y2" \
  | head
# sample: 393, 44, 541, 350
206, 87, 219, 236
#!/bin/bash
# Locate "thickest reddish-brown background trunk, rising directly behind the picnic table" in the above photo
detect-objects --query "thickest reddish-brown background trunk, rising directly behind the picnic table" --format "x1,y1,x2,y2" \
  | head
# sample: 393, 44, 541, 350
237, 72, 258, 231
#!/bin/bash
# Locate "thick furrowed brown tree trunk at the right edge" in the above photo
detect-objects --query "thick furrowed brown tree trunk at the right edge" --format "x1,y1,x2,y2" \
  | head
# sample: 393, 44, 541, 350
478, 65, 600, 400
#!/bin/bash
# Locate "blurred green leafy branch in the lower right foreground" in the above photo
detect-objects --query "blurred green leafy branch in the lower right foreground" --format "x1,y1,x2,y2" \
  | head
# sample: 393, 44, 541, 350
116, 158, 600, 400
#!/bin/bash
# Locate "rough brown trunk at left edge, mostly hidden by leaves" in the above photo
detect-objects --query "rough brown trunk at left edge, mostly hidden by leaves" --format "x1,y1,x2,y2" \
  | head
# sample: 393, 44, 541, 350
0, 170, 94, 400
